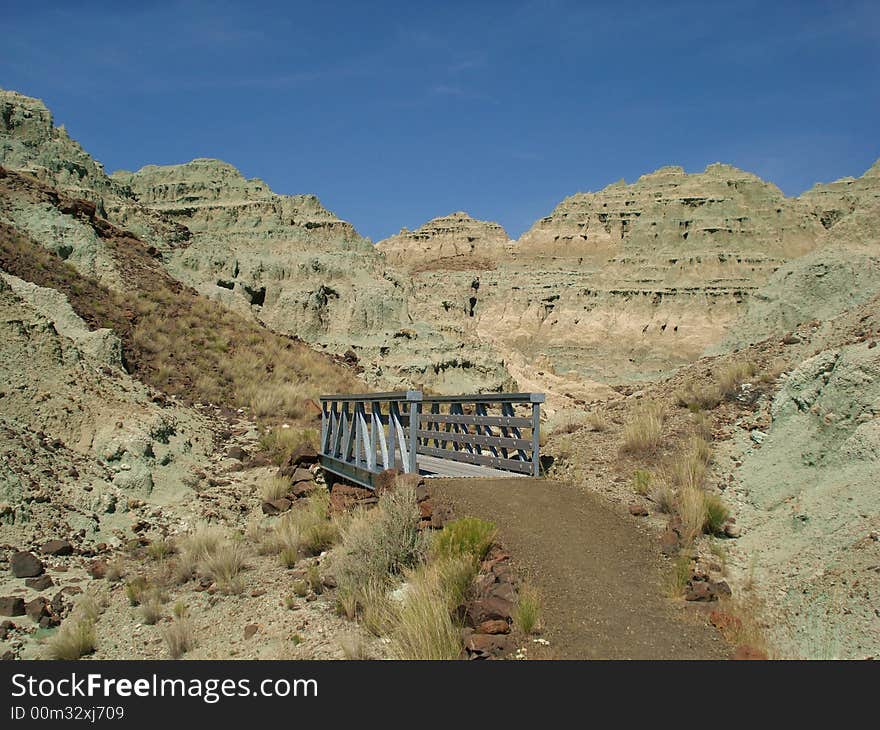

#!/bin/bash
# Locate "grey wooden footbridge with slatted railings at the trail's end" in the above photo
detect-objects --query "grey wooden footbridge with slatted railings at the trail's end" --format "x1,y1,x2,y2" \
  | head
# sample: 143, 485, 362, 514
320, 390, 544, 488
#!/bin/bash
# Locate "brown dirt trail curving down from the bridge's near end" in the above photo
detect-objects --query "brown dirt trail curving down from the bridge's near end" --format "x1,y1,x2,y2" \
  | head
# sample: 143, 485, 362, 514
430, 479, 729, 659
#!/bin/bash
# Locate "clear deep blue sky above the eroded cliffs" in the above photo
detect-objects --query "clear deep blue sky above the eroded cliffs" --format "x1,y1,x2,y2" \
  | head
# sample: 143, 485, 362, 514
0, 0, 880, 240
